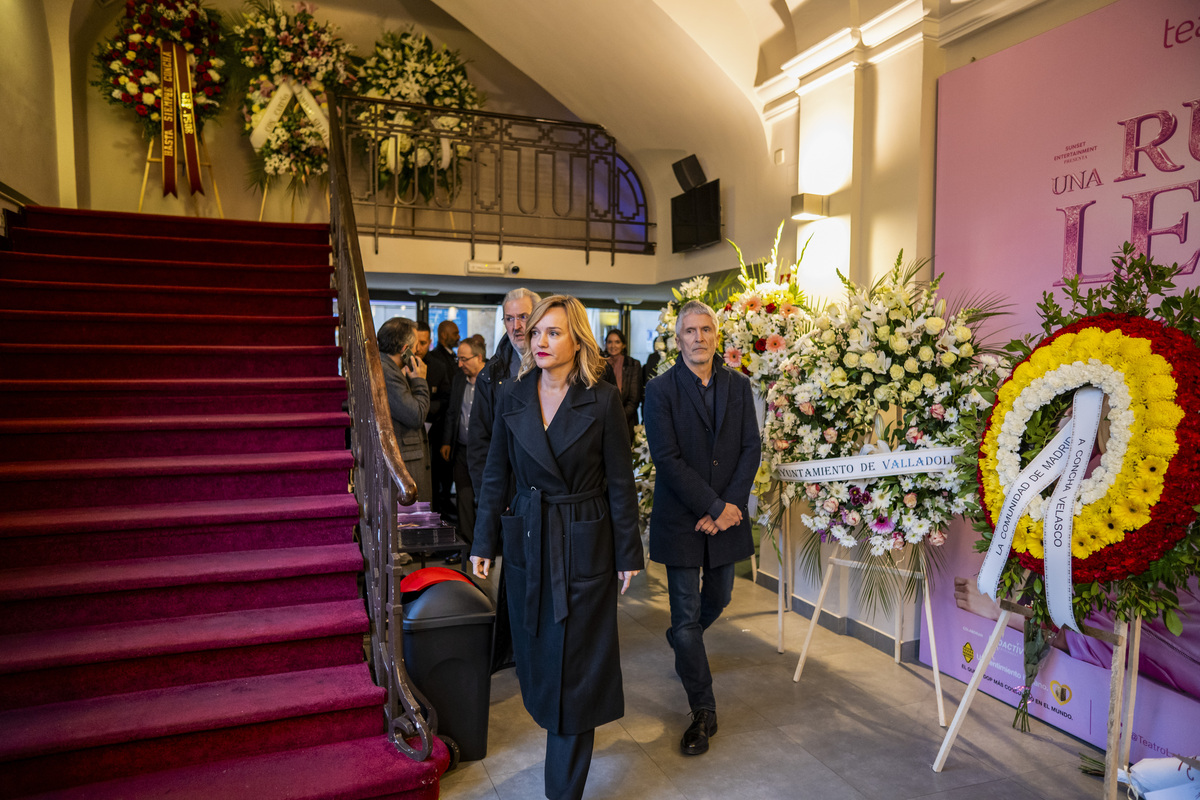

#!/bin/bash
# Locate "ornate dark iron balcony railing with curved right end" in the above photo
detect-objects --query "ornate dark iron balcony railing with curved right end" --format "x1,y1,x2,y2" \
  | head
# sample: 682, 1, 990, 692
337, 95, 654, 259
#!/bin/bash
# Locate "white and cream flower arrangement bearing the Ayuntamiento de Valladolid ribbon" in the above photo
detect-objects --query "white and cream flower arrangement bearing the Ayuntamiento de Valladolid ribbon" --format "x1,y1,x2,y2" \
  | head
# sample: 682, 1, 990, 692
763, 253, 1001, 566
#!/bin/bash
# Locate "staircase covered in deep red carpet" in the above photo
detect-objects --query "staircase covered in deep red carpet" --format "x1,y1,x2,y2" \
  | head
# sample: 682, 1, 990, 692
0, 207, 448, 800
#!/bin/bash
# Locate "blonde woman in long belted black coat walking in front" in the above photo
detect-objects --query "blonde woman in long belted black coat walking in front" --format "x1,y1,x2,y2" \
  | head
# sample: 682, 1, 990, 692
470, 295, 644, 800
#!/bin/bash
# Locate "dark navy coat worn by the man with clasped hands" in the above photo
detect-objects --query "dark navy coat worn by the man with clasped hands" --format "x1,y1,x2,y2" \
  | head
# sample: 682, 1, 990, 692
646, 357, 762, 566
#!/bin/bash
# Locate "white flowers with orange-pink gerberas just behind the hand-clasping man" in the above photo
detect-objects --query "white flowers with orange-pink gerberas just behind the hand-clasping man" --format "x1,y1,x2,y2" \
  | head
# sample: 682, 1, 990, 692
716, 224, 810, 396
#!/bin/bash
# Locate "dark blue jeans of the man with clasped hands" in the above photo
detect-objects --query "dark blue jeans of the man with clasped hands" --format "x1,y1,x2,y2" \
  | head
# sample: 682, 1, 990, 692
667, 564, 734, 711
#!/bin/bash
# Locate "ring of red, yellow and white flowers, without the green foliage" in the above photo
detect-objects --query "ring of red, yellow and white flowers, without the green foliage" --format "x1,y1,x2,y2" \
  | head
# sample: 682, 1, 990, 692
979, 314, 1200, 583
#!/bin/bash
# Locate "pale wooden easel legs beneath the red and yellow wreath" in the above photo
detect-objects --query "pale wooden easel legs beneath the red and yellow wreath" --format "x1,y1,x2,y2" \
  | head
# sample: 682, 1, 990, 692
934, 600, 1141, 800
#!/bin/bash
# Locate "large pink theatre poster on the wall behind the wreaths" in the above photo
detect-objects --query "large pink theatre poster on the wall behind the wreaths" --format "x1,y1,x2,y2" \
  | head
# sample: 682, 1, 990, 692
920, 0, 1200, 759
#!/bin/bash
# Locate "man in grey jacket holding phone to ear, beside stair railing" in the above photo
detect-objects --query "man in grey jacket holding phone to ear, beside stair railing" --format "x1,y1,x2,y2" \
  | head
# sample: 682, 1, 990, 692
376, 317, 432, 503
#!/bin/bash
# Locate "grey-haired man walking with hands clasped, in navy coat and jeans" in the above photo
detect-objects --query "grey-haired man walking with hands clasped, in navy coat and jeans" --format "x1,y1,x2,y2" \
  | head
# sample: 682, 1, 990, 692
646, 301, 762, 756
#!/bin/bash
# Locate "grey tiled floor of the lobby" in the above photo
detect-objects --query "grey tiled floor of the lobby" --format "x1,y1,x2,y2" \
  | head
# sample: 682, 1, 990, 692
442, 565, 1102, 800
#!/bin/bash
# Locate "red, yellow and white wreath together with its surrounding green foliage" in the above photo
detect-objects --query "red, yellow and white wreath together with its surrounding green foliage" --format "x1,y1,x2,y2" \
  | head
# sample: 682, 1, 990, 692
977, 243, 1200, 633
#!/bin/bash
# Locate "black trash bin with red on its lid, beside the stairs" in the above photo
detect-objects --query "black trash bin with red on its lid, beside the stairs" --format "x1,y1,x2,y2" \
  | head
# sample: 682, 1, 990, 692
401, 567, 496, 762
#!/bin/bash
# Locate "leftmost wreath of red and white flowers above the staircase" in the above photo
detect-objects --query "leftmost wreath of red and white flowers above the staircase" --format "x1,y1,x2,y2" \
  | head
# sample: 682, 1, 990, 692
92, 0, 227, 137
